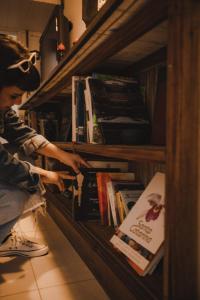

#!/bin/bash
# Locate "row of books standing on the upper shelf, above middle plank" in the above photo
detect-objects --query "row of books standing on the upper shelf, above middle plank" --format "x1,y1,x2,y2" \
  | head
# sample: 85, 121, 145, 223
72, 76, 150, 145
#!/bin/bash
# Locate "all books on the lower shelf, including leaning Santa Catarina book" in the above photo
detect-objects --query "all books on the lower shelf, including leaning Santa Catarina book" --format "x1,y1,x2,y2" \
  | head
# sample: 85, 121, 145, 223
44, 160, 165, 276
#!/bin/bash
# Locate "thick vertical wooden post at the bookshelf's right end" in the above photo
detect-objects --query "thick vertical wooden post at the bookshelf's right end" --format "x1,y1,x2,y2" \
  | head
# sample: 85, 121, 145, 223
164, 0, 200, 300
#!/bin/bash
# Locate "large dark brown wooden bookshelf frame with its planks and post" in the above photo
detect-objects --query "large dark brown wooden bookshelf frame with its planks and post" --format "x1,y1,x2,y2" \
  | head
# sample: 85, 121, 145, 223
21, 0, 200, 300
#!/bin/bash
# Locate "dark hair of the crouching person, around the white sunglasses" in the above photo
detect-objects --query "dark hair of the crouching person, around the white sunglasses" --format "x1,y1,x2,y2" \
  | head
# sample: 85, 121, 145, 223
0, 34, 40, 91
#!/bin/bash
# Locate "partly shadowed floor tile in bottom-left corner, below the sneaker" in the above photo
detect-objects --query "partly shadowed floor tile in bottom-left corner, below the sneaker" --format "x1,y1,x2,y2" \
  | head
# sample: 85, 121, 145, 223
0, 257, 37, 296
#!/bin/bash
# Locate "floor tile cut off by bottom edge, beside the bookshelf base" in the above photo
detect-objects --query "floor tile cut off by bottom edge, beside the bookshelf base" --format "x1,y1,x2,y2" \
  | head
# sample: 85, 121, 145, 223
40, 280, 109, 300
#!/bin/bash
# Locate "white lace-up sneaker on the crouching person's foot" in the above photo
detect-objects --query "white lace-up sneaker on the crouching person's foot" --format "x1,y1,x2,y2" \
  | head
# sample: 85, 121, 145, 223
0, 232, 49, 257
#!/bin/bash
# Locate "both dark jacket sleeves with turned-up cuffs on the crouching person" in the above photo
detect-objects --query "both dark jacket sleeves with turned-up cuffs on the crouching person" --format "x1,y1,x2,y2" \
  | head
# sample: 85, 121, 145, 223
0, 108, 49, 193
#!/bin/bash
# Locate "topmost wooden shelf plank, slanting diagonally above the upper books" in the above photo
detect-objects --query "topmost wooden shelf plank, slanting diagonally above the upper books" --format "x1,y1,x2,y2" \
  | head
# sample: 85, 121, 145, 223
21, 0, 167, 109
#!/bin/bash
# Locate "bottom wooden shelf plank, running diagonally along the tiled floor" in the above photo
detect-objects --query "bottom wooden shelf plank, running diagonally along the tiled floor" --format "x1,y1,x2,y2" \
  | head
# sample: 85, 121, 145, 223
47, 191, 163, 300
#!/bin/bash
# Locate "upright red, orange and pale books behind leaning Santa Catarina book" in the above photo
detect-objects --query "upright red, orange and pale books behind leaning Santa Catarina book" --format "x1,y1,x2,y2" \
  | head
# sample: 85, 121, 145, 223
96, 172, 144, 228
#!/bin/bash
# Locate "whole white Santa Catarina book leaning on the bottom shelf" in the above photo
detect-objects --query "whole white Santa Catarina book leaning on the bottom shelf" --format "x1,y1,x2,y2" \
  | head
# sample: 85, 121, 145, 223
110, 172, 165, 276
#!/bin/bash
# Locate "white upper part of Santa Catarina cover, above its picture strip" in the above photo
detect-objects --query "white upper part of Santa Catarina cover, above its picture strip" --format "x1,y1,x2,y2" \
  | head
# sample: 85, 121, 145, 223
119, 172, 165, 254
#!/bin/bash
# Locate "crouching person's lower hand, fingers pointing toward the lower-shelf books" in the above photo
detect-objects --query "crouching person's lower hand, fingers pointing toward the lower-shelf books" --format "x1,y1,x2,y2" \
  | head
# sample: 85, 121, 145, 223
41, 170, 75, 192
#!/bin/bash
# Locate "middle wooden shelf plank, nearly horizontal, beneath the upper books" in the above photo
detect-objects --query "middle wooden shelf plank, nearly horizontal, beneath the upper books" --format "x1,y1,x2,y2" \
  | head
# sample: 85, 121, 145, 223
54, 142, 165, 162
